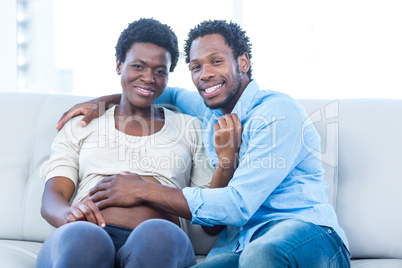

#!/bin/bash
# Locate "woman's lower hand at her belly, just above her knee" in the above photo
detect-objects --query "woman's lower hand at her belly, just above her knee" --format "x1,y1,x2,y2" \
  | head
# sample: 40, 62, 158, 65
64, 198, 105, 228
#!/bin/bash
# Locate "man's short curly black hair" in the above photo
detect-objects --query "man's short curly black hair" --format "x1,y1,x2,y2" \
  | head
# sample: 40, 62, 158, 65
184, 20, 251, 79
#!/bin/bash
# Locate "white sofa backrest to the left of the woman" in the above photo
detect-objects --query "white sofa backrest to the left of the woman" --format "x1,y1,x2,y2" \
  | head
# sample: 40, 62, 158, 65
0, 93, 87, 242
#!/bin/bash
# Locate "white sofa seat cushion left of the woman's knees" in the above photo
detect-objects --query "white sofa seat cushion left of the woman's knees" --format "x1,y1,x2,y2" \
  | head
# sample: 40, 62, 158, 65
0, 239, 42, 268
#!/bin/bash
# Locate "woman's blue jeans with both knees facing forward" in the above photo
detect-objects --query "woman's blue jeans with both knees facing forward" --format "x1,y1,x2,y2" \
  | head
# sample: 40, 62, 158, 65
37, 219, 196, 268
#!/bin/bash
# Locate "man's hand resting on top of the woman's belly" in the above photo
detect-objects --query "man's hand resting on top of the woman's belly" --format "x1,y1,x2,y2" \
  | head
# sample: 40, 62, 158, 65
89, 172, 147, 209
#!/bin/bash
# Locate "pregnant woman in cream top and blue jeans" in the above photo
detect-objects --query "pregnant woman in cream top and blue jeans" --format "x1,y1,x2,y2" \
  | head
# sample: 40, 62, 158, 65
37, 19, 240, 267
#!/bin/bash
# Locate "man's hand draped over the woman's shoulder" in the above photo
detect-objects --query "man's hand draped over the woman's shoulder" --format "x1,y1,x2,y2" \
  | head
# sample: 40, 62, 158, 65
56, 94, 121, 131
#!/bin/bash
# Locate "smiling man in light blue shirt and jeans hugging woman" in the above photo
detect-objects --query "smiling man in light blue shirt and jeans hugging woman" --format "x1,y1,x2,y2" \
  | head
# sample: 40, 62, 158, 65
58, 21, 350, 267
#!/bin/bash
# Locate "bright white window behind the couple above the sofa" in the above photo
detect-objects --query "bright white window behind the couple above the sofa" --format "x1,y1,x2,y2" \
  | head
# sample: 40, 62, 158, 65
0, 0, 402, 99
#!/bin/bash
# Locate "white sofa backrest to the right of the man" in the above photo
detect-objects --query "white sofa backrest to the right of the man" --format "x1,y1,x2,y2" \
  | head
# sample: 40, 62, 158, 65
299, 99, 402, 258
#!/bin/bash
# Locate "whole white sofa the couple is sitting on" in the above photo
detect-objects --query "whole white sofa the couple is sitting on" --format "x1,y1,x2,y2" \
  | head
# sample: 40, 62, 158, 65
0, 93, 402, 268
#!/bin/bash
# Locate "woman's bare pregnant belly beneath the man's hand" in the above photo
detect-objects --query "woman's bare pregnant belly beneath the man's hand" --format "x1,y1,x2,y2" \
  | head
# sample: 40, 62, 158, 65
101, 177, 180, 229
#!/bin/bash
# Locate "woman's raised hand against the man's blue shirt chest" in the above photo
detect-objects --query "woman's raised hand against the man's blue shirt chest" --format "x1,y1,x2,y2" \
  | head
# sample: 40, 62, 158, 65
214, 114, 243, 168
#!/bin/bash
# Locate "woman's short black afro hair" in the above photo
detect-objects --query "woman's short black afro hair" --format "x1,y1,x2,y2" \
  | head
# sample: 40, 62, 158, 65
116, 18, 179, 72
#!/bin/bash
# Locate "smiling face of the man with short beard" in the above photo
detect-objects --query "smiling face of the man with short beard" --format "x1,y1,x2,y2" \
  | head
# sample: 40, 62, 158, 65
189, 34, 249, 113
